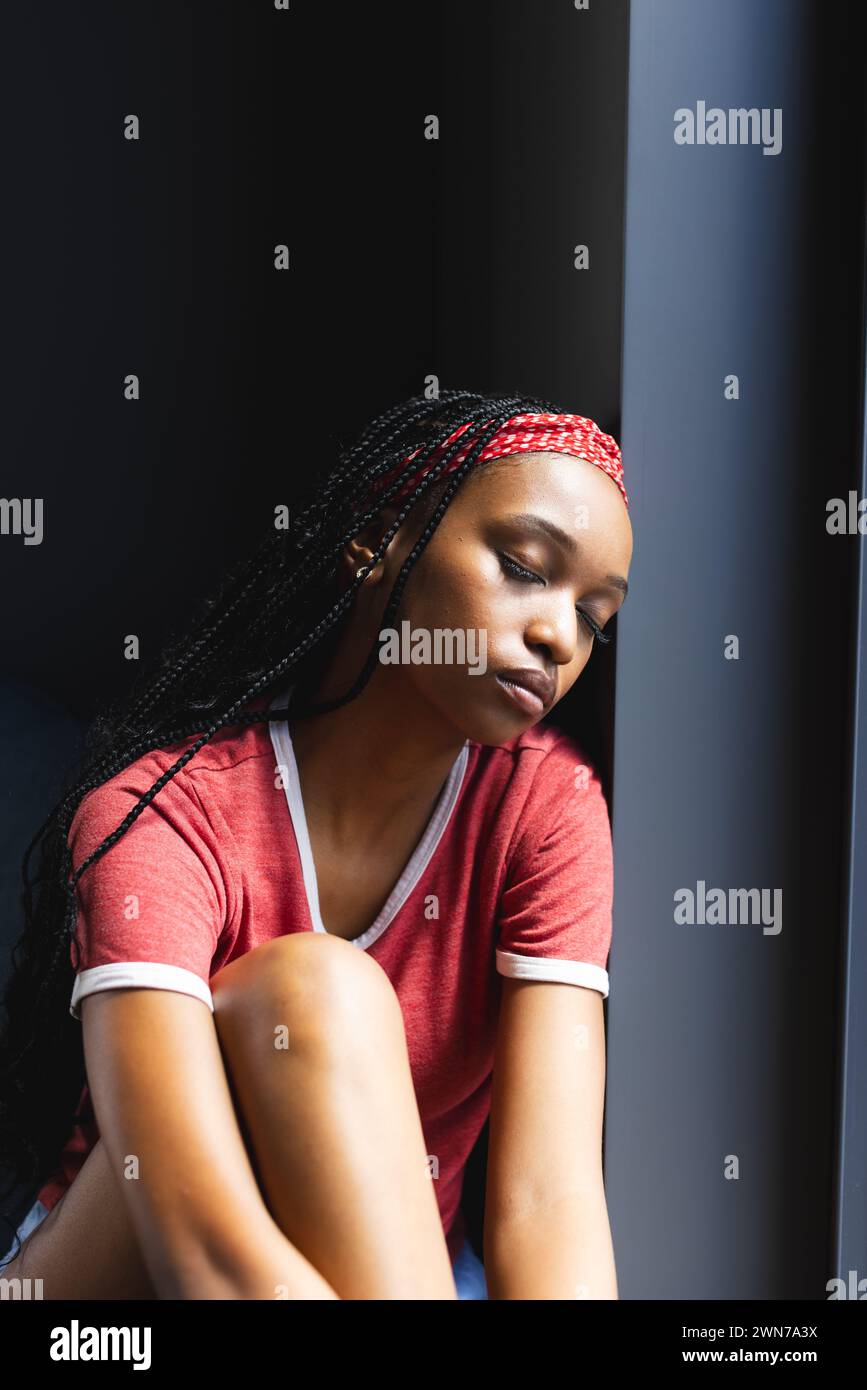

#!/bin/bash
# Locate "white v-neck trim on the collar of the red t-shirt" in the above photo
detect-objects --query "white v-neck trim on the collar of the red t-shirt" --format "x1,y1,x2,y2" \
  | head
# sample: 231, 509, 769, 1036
268, 685, 470, 951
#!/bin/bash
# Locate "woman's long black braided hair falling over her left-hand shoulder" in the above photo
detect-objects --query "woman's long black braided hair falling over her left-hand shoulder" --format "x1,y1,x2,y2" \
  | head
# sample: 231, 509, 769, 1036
0, 380, 561, 1252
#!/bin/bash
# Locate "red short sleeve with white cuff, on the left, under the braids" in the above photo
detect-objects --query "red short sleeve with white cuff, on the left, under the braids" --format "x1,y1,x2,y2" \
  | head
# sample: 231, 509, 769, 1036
68, 773, 226, 1019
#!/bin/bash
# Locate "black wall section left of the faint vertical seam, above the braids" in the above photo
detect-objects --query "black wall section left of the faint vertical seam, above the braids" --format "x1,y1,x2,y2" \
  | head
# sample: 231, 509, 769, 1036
0, 3, 438, 716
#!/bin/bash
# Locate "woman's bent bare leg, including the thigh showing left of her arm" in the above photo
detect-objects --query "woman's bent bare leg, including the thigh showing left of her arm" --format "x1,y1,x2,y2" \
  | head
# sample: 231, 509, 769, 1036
1, 933, 454, 1300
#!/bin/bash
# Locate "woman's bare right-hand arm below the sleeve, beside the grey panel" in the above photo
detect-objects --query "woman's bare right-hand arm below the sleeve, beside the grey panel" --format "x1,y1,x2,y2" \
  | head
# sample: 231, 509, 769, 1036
485, 979, 617, 1298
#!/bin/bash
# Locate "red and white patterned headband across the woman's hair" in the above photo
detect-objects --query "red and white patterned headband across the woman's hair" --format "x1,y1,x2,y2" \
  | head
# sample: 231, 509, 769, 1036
372, 414, 629, 509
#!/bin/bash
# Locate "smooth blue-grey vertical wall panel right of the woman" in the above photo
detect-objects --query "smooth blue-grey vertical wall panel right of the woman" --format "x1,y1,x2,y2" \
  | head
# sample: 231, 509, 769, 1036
606, 0, 856, 1298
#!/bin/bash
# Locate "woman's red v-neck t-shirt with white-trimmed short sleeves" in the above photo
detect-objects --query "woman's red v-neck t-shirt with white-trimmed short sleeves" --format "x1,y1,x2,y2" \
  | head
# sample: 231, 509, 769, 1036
39, 688, 613, 1258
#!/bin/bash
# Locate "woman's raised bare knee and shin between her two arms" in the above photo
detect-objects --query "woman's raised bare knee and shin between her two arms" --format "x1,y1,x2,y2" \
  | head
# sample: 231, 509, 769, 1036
211, 931, 456, 1298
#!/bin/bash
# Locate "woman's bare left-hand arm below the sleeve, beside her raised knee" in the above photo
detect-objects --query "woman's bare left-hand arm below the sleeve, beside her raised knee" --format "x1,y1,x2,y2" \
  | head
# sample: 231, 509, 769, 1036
82, 988, 338, 1300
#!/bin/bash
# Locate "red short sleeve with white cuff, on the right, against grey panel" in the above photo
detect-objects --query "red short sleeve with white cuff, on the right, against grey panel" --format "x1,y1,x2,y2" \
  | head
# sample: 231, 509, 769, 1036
496, 735, 614, 998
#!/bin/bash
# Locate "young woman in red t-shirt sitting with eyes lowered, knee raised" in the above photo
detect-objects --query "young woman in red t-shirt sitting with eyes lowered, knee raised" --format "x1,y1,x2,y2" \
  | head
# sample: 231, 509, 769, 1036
0, 391, 632, 1298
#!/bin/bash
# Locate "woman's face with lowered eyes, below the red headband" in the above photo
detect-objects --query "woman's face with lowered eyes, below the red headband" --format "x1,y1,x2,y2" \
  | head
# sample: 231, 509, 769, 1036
343, 453, 632, 745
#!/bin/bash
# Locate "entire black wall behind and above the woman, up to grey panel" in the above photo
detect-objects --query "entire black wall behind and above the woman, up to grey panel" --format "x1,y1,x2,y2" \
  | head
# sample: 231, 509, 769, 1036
0, 0, 625, 716
